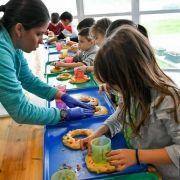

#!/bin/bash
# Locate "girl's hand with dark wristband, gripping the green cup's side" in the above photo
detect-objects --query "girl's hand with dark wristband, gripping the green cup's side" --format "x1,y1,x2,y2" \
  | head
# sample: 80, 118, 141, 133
107, 149, 136, 171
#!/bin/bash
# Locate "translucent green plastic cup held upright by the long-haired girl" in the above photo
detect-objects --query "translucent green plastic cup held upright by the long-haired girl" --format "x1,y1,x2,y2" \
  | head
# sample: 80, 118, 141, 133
91, 136, 111, 163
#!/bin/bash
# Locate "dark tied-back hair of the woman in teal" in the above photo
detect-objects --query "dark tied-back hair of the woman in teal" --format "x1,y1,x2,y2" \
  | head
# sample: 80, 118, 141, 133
0, 0, 49, 32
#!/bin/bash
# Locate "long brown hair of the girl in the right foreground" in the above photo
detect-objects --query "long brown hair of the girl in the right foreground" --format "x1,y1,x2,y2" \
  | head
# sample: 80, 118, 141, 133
94, 25, 180, 133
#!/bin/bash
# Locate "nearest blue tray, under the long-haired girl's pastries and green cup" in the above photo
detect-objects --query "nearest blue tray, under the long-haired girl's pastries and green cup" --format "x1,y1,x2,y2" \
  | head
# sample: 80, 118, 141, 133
44, 116, 146, 180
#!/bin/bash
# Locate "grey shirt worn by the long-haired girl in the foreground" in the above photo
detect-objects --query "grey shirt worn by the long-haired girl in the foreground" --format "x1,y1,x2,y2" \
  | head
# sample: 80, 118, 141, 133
104, 91, 180, 180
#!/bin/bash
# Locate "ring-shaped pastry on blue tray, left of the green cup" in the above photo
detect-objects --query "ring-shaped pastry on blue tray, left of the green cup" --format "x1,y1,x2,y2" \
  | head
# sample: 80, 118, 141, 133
62, 129, 93, 150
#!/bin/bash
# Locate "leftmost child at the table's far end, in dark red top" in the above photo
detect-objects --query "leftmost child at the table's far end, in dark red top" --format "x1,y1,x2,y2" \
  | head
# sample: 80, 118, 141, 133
48, 13, 64, 35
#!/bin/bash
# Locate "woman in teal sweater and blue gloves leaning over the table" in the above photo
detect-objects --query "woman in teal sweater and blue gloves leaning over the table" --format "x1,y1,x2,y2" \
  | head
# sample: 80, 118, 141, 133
0, 0, 93, 125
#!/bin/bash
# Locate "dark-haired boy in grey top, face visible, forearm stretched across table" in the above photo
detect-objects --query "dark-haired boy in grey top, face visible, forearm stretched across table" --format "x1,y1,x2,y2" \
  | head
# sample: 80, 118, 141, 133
56, 28, 98, 68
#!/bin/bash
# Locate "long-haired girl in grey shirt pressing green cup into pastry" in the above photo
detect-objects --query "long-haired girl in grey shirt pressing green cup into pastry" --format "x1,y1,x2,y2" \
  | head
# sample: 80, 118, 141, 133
81, 25, 180, 179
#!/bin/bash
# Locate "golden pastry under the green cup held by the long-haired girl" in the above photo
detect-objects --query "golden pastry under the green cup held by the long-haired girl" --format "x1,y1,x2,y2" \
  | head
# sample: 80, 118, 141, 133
85, 155, 116, 174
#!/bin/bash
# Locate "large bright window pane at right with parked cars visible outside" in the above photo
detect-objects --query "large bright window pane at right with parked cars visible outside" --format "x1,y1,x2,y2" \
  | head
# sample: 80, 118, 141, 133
140, 13, 180, 69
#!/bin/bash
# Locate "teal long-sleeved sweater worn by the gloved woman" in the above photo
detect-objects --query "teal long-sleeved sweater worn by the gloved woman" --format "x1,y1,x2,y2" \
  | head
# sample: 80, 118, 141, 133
0, 26, 60, 125
